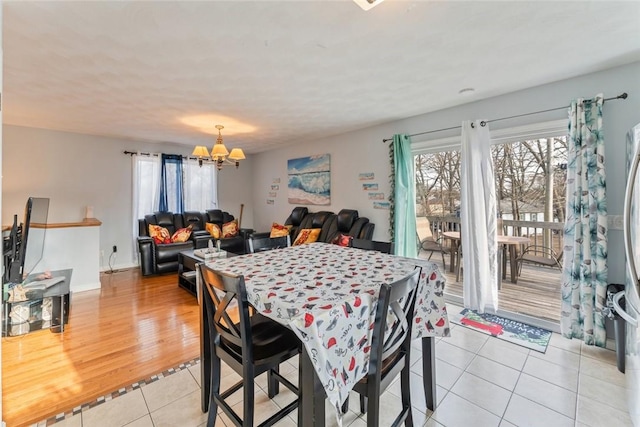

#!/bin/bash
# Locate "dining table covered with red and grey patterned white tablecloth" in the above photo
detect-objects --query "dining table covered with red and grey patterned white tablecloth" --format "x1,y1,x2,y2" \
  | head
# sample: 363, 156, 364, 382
199, 242, 450, 426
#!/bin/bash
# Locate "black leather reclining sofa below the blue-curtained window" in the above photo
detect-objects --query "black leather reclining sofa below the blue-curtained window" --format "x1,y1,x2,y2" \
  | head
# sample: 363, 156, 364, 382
138, 209, 246, 276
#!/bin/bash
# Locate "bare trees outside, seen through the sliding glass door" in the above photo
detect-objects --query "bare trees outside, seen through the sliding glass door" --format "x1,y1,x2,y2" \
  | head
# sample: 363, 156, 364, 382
415, 136, 568, 227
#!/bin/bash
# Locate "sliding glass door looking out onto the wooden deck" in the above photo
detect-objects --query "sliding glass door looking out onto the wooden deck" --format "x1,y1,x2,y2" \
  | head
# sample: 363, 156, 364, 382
415, 133, 567, 322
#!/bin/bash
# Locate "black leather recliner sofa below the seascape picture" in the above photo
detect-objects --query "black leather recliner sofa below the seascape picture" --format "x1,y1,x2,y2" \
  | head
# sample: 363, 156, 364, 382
284, 206, 375, 243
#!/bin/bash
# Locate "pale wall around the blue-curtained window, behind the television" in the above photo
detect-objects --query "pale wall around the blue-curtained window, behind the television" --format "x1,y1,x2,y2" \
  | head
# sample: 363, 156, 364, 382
2, 125, 253, 269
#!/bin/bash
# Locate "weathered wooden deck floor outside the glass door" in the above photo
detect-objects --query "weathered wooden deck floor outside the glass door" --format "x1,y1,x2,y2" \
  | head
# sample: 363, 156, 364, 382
420, 252, 562, 324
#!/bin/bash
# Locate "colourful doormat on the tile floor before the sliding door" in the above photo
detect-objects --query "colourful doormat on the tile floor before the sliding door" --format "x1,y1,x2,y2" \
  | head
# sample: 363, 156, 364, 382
449, 308, 551, 353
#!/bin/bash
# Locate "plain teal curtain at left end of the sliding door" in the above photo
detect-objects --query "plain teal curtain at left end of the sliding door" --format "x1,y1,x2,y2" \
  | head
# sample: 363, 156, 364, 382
392, 134, 418, 258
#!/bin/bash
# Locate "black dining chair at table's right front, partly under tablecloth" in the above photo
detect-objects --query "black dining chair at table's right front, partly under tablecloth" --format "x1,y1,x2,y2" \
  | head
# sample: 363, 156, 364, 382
342, 267, 422, 427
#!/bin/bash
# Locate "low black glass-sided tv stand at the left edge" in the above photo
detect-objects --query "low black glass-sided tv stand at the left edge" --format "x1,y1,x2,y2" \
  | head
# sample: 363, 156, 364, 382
2, 269, 73, 336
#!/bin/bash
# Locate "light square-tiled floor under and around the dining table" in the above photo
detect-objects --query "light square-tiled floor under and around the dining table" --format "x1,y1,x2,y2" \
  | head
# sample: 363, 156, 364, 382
37, 310, 632, 427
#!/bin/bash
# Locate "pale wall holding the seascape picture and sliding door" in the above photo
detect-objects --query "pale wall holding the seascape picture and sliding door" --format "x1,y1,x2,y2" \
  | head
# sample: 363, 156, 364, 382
253, 62, 640, 283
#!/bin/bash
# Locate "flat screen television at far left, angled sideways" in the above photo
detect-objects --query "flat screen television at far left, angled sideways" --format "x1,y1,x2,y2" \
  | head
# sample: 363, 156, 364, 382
4, 197, 49, 283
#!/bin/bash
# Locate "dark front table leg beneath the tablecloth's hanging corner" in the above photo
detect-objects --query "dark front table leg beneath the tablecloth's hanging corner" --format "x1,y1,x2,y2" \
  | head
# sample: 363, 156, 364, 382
298, 346, 326, 426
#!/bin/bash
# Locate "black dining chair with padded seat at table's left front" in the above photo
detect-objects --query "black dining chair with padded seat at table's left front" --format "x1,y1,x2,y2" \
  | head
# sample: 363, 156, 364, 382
200, 264, 302, 427
